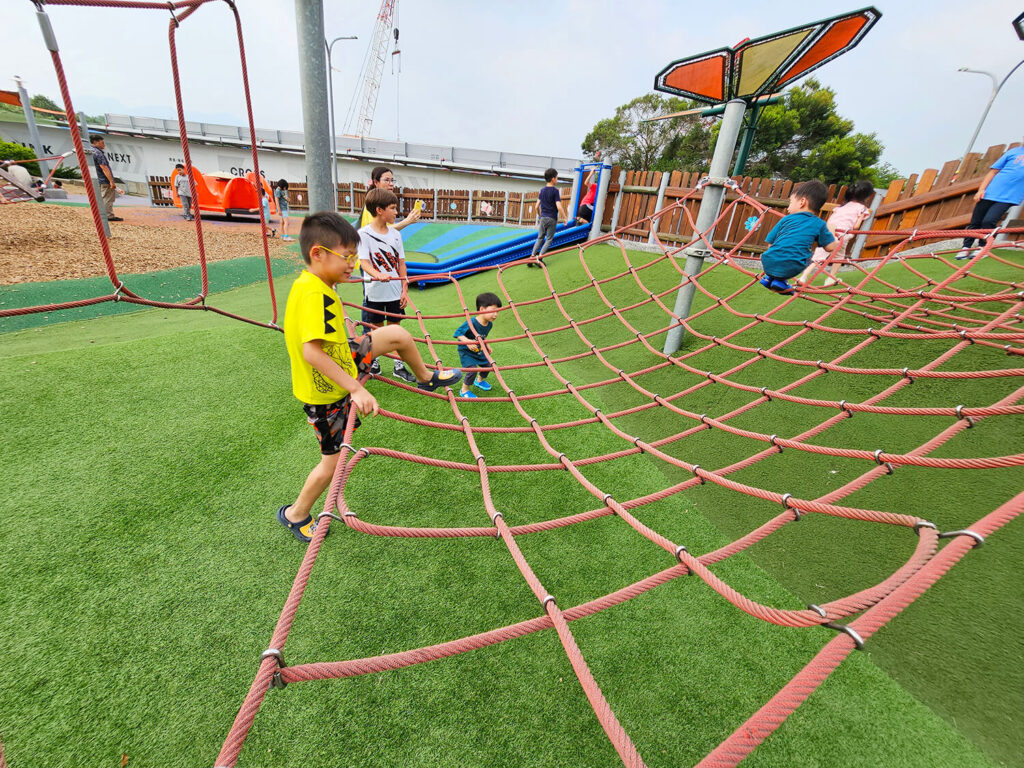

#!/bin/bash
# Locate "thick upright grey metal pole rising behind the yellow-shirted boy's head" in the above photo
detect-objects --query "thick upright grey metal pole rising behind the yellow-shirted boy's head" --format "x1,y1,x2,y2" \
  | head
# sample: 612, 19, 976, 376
295, 0, 336, 213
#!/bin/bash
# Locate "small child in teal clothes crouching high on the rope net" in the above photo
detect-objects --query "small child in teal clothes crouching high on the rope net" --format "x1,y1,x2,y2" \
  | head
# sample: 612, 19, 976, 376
761, 179, 839, 294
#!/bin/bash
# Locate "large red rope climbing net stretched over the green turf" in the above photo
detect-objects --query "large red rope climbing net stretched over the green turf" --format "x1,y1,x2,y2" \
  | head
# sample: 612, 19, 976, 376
216, 182, 1024, 766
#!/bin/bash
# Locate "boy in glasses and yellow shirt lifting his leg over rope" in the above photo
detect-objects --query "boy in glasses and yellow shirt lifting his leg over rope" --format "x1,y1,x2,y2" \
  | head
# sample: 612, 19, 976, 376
278, 211, 462, 542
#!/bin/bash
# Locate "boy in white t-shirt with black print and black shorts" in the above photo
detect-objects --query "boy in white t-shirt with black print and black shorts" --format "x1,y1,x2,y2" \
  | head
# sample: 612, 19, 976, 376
358, 187, 416, 384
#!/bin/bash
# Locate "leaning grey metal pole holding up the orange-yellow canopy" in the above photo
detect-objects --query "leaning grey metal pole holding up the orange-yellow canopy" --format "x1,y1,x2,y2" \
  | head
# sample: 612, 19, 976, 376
664, 98, 746, 354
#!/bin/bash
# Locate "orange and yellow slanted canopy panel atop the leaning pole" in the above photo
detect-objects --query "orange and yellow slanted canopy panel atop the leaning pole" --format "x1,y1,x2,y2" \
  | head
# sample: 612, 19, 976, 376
654, 7, 882, 103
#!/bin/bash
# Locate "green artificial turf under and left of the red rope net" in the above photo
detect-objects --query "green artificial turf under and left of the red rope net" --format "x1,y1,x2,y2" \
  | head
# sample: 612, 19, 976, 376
0, 247, 1024, 768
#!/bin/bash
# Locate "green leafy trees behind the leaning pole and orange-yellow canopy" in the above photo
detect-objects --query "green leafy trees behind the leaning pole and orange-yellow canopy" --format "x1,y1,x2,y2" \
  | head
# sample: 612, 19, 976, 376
583, 78, 899, 186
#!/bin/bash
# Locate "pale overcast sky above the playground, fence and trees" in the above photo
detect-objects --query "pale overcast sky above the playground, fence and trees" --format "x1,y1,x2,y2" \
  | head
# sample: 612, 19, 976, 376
8, 0, 1024, 172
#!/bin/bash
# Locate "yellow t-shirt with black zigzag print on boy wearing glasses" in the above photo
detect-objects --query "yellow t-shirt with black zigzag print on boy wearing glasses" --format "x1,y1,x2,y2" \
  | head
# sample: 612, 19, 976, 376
285, 269, 358, 406
